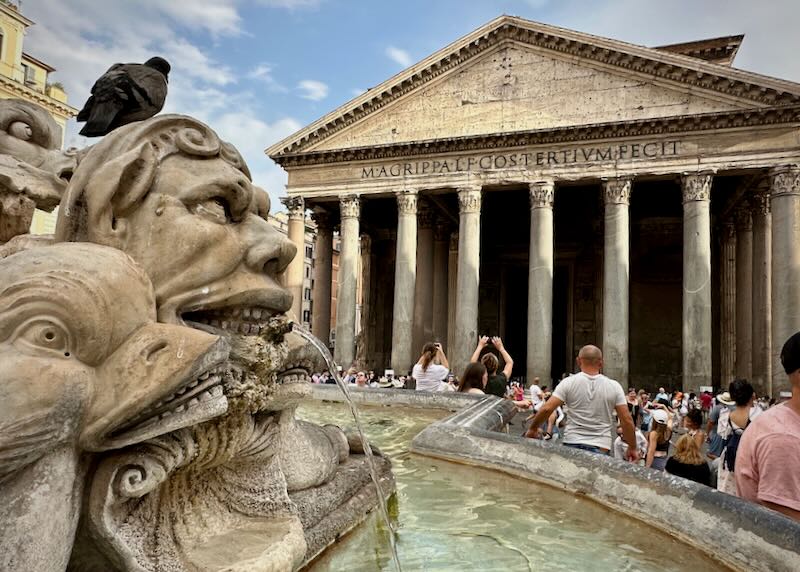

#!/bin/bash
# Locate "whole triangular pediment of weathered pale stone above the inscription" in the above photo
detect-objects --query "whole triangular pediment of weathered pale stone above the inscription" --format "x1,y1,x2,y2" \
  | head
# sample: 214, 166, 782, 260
267, 16, 800, 157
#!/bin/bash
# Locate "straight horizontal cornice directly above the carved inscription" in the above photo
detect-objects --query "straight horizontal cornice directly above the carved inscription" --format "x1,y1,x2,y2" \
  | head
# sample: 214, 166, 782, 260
274, 105, 800, 167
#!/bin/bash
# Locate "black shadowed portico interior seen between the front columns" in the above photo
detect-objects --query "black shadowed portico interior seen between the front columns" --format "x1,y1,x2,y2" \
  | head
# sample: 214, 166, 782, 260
330, 174, 750, 389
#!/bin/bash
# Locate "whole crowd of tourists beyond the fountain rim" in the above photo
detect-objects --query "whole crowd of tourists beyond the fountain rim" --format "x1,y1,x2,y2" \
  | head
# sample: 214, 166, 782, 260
312, 332, 800, 520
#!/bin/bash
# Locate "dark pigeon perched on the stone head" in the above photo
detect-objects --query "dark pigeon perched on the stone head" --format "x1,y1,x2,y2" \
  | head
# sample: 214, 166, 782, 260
77, 57, 170, 137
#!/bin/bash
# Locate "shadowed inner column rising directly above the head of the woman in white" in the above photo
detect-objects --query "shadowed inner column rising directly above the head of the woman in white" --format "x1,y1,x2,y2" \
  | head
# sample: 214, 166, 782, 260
411, 199, 434, 355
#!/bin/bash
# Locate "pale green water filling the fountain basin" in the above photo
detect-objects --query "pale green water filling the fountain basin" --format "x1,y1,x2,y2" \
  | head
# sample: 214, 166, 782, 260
299, 403, 722, 572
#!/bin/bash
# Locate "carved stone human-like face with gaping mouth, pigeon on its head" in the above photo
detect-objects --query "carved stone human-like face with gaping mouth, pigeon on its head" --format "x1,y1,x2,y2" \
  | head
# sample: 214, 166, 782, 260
56, 115, 296, 334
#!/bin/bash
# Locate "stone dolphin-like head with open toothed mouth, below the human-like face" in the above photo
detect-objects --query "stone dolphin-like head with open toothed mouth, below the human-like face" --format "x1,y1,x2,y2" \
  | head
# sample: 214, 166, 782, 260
0, 243, 227, 476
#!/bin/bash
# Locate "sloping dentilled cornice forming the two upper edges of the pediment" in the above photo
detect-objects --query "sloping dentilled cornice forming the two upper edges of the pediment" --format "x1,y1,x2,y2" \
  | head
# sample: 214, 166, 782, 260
266, 16, 800, 162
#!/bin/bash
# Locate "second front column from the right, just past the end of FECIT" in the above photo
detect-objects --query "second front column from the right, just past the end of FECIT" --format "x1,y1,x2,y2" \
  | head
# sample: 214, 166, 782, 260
682, 173, 712, 392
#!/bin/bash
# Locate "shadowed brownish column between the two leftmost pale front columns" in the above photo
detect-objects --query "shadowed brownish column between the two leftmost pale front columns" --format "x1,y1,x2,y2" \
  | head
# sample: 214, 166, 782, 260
311, 211, 333, 346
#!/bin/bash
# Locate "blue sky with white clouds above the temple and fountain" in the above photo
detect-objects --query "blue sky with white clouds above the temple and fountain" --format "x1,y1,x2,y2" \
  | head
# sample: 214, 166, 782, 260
22, 0, 800, 212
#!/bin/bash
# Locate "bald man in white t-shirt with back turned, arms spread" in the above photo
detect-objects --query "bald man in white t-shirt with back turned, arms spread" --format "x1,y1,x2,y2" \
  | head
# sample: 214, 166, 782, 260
527, 346, 639, 461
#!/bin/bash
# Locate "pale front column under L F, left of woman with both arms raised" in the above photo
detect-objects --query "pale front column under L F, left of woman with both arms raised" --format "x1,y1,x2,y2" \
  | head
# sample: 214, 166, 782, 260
448, 186, 481, 376
